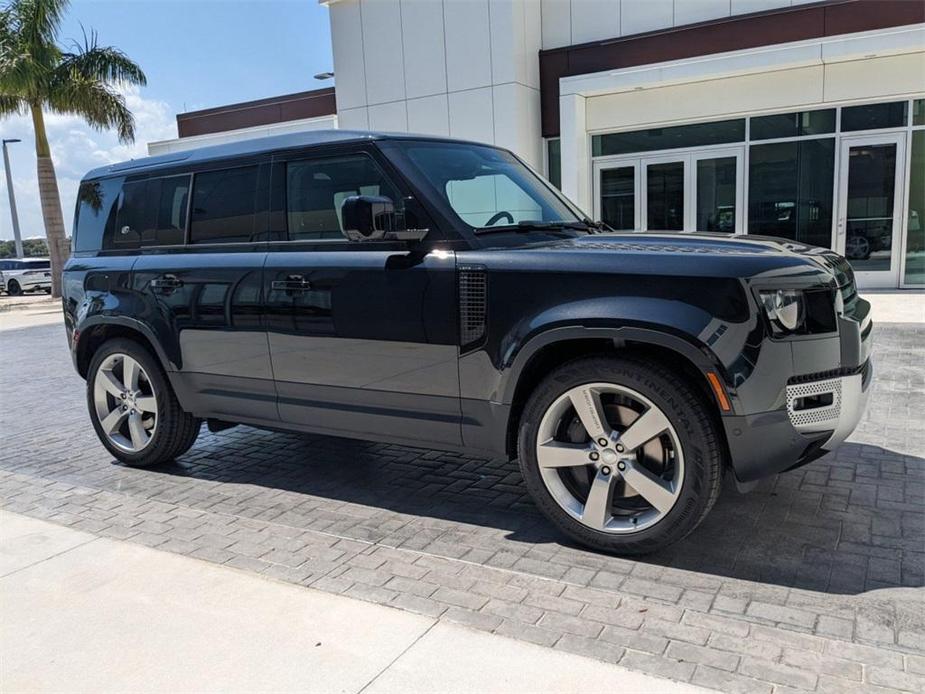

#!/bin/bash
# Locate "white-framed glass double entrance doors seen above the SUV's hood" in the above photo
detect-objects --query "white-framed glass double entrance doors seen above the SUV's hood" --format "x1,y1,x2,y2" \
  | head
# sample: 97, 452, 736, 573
594, 147, 744, 233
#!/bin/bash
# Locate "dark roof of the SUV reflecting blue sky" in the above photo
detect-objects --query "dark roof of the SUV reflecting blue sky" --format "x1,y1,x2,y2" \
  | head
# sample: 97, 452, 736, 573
84, 130, 476, 179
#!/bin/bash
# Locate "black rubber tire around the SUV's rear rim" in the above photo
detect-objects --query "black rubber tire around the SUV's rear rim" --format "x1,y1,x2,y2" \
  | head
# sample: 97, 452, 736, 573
87, 338, 201, 467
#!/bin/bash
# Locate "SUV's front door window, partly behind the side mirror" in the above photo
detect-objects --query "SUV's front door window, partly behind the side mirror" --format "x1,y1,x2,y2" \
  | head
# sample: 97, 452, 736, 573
286, 154, 401, 241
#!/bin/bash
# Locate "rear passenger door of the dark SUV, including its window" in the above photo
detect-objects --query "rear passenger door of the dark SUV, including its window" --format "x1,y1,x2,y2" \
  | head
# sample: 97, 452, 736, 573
128, 161, 278, 421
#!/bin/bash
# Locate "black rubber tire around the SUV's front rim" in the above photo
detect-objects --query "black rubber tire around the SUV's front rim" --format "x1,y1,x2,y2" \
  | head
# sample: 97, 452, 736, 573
518, 356, 724, 555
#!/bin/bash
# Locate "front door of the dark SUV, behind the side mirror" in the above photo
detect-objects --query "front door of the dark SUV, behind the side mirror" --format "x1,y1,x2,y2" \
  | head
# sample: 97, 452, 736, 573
264, 149, 460, 444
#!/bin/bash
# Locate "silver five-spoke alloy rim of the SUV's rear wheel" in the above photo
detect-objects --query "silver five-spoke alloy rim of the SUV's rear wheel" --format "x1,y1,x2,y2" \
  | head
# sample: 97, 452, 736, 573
93, 353, 157, 453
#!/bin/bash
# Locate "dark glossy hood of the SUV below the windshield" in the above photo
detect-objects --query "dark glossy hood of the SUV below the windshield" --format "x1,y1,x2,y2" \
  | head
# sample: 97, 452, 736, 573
488, 232, 853, 287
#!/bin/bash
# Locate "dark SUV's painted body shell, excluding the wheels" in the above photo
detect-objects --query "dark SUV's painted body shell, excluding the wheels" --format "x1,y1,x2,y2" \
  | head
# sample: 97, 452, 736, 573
63, 131, 872, 556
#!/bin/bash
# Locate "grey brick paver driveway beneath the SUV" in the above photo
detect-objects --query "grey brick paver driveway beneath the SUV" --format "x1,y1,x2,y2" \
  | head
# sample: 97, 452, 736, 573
0, 316, 925, 692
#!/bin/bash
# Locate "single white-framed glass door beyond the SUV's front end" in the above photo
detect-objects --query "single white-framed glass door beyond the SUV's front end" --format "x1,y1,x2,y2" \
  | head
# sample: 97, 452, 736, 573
835, 133, 905, 287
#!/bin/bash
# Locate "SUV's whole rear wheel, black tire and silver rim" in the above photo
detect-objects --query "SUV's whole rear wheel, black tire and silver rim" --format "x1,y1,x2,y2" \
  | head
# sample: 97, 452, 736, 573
87, 338, 200, 467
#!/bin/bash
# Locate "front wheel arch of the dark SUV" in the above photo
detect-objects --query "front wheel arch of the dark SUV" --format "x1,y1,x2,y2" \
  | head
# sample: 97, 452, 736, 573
505, 327, 728, 468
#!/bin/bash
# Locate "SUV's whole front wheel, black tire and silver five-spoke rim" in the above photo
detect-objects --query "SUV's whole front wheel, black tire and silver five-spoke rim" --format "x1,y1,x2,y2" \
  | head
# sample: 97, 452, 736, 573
518, 357, 722, 554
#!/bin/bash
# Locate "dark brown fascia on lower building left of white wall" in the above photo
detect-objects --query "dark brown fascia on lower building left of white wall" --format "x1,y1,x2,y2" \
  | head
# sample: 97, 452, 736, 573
177, 87, 337, 137
